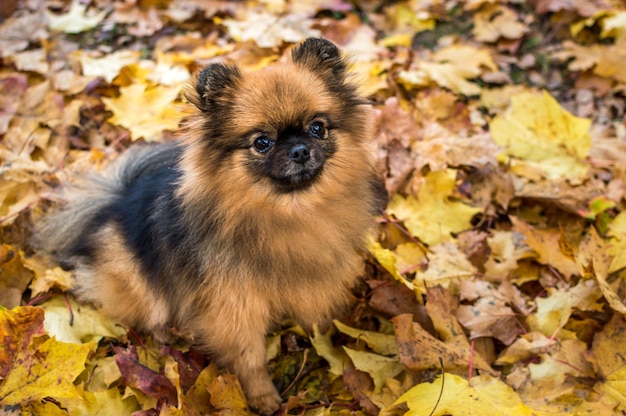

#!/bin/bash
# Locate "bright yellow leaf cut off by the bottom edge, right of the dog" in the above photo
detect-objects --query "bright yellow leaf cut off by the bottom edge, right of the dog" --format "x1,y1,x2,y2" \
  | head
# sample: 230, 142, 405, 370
396, 373, 533, 416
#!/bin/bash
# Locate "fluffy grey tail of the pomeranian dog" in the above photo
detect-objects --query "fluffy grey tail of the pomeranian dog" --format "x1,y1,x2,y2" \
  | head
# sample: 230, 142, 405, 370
33, 143, 180, 262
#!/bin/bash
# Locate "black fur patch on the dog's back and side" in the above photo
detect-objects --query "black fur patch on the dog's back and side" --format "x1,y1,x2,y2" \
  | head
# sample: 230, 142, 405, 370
69, 144, 211, 293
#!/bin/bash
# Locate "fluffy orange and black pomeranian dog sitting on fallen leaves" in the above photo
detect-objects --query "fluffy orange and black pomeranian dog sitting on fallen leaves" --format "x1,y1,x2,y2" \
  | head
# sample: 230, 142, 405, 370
40, 39, 385, 414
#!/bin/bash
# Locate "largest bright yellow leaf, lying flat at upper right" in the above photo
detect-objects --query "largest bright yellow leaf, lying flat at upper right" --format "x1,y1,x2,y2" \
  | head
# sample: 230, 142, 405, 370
489, 91, 591, 179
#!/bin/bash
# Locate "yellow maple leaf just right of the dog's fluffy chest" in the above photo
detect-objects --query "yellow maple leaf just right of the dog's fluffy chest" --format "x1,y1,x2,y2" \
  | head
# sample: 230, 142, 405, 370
387, 169, 481, 245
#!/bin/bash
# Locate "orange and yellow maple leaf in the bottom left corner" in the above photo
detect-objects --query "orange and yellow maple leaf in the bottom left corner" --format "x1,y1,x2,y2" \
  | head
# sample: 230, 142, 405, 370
0, 306, 96, 408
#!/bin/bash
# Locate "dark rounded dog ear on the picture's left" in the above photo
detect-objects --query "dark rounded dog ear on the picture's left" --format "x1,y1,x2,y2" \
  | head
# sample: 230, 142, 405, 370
194, 64, 241, 111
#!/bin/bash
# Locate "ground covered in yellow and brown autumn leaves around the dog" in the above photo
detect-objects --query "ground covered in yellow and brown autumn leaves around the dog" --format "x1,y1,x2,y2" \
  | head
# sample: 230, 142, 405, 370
0, 0, 626, 416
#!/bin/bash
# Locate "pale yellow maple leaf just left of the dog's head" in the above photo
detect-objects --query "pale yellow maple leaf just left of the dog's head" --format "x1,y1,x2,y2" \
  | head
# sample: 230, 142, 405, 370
102, 84, 182, 141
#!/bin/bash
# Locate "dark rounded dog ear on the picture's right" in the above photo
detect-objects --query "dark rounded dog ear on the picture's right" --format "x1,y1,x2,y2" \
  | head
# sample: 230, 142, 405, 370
291, 38, 348, 80
